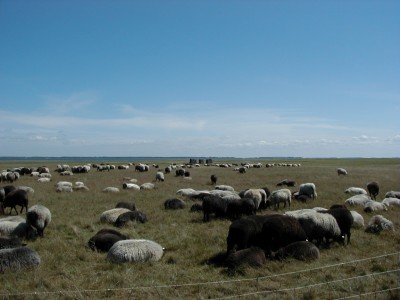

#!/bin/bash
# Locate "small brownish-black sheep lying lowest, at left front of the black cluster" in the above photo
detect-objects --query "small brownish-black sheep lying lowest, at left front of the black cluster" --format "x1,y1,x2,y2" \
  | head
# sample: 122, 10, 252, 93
225, 247, 267, 269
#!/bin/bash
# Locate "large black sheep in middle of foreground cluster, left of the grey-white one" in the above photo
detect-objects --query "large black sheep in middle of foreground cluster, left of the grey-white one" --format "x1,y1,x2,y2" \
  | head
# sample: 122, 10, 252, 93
260, 215, 307, 254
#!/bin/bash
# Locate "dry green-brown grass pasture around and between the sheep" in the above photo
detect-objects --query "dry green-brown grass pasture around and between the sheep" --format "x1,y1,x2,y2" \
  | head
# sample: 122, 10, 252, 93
0, 159, 400, 299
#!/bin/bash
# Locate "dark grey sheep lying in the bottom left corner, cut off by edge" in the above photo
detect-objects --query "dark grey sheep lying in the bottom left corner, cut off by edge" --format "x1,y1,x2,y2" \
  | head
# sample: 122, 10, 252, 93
0, 247, 40, 273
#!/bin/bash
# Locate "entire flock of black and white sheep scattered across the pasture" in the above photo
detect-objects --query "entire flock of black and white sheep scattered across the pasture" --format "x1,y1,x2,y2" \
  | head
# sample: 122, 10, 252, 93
0, 161, 400, 272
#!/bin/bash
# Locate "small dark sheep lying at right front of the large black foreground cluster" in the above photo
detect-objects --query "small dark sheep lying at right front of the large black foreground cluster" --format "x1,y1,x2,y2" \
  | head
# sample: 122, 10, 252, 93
272, 241, 320, 260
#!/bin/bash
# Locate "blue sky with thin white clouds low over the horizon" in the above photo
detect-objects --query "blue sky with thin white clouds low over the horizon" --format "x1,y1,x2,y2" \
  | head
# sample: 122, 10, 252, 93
0, 0, 400, 157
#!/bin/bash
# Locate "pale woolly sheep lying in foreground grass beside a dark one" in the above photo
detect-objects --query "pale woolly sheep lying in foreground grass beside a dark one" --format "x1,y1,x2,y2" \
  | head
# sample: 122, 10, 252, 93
107, 240, 164, 263
